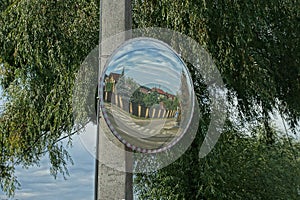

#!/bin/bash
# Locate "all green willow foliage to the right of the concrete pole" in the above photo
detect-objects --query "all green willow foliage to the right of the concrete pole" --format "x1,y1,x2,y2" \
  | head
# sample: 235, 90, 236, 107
133, 0, 300, 199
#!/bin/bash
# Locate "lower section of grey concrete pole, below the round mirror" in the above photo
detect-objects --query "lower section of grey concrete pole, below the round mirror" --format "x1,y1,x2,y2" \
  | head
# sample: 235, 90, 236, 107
98, 114, 132, 200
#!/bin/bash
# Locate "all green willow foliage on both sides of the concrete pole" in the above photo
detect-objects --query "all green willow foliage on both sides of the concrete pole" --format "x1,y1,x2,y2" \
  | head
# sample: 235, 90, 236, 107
0, 0, 300, 199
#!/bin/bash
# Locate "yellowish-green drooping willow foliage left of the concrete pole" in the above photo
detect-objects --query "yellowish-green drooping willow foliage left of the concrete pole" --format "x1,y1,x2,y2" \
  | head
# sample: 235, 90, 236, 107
0, 0, 99, 195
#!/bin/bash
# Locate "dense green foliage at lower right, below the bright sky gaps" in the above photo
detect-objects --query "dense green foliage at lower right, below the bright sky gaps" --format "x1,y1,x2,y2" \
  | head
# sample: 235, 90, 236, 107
135, 122, 300, 200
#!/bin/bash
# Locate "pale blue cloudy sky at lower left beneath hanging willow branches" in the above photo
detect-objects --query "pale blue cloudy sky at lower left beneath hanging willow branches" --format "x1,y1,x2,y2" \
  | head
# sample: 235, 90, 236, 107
0, 129, 95, 200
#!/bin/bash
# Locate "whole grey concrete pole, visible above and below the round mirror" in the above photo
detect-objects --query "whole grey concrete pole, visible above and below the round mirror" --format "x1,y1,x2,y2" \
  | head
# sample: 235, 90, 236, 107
95, 0, 133, 200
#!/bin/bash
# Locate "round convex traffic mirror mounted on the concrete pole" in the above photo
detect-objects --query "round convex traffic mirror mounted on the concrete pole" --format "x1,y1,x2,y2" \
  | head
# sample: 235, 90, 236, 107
100, 38, 195, 153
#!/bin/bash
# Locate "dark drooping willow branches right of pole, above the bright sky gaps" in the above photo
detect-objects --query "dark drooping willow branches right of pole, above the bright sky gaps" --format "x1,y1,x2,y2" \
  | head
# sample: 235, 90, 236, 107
133, 0, 300, 133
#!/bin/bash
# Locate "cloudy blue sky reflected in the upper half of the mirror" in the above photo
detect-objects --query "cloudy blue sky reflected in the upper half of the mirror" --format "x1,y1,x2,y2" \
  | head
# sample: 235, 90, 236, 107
105, 38, 191, 95
